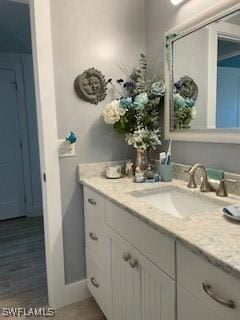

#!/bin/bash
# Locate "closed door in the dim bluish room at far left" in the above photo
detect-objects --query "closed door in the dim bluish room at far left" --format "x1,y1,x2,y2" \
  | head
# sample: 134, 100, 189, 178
0, 68, 25, 220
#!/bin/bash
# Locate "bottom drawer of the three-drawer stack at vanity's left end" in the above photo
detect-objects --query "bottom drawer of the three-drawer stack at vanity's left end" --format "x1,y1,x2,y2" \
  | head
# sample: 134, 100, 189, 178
86, 249, 106, 313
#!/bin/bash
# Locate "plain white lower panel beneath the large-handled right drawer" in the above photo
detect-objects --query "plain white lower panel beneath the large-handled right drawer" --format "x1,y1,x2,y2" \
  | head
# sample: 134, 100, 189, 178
177, 285, 223, 320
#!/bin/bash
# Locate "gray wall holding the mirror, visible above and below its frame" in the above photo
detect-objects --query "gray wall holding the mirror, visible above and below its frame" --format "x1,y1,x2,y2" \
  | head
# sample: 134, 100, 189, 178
146, 0, 240, 173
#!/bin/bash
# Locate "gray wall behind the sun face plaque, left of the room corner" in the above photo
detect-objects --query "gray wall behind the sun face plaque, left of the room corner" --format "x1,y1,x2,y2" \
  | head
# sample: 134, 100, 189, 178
51, 0, 145, 283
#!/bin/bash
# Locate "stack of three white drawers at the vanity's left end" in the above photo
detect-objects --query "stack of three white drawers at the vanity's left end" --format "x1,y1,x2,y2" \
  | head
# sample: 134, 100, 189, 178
84, 187, 111, 319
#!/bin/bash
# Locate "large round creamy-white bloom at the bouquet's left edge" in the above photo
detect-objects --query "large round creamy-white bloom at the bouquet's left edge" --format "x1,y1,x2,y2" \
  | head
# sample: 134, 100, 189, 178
102, 100, 126, 124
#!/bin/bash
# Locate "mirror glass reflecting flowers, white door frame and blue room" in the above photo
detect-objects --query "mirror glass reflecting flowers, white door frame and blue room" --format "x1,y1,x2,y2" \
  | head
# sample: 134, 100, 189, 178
170, 12, 240, 130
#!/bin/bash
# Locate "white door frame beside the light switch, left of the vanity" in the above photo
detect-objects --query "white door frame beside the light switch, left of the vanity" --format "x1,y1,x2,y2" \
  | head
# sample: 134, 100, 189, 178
9, 0, 66, 308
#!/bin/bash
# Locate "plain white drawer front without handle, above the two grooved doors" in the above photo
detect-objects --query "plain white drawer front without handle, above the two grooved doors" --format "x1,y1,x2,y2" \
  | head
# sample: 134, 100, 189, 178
105, 200, 175, 278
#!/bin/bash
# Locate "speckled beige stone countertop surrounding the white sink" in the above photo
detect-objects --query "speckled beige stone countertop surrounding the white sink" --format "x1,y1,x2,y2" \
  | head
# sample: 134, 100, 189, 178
80, 169, 240, 279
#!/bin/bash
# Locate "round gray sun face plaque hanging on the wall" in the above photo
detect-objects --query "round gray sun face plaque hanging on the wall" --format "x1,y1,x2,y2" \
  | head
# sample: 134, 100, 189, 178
74, 68, 107, 104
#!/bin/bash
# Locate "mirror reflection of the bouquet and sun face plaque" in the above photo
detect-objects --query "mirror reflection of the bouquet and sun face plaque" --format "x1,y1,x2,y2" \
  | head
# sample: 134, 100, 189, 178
173, 76, 198, 129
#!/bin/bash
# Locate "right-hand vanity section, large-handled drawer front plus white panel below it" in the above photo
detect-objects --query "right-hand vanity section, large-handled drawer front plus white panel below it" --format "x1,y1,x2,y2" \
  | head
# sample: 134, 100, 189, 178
177, 244, 240, 320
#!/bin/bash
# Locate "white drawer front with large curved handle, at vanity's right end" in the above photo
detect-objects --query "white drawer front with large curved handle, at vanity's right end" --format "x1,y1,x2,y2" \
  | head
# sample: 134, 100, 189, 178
177, 244, 240, 320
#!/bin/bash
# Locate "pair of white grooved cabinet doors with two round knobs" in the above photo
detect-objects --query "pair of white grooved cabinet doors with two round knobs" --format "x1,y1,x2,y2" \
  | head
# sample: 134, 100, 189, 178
109, 232, 175, 320
